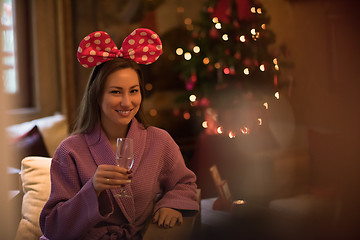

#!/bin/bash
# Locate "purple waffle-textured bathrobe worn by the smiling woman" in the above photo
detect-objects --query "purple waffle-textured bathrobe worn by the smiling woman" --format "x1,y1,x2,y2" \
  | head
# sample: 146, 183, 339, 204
40, 118, 199, 240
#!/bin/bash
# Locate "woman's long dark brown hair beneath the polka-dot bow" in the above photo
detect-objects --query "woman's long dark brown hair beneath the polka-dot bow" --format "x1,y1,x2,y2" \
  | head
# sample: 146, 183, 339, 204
72, 58, 147, 134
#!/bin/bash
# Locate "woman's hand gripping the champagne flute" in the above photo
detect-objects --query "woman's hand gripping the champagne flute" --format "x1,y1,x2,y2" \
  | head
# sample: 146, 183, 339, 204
92, 165, 132, 196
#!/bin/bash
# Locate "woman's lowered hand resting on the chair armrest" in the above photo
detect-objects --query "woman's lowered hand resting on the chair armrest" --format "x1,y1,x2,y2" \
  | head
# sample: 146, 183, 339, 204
153, 208, 183, 228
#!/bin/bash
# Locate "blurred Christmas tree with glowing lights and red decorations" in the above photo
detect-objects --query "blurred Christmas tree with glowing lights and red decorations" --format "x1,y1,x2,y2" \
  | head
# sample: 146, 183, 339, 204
176, 0, 288, 138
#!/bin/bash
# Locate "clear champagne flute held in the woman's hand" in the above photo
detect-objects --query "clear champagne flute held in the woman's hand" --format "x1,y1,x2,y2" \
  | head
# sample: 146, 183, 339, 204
116, 138, 134, 198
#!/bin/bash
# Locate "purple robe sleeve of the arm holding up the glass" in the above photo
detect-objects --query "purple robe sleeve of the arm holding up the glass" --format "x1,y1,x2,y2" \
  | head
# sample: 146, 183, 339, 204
40, 136, 112, 240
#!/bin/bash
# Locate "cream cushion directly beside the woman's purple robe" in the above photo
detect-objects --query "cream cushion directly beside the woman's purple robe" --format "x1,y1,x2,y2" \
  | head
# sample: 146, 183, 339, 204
15, 157, 51, 240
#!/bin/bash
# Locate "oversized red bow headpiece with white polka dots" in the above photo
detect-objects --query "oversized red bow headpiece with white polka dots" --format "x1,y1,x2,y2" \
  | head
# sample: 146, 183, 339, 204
77, 28, 162, 68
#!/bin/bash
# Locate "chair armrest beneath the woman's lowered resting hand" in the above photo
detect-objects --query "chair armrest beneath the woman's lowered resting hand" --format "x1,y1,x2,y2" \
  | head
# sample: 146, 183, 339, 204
143, 216, 200, 240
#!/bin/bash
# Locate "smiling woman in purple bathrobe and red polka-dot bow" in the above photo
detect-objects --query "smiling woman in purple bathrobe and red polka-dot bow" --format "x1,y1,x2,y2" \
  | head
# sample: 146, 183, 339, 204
40, 29, 199, 240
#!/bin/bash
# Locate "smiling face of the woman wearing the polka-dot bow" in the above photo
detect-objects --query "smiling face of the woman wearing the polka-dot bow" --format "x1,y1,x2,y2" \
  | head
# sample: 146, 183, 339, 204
100, 68, 141, 131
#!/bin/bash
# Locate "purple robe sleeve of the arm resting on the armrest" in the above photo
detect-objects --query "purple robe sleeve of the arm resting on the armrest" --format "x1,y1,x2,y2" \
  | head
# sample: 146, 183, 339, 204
150, 128, 199, 213
